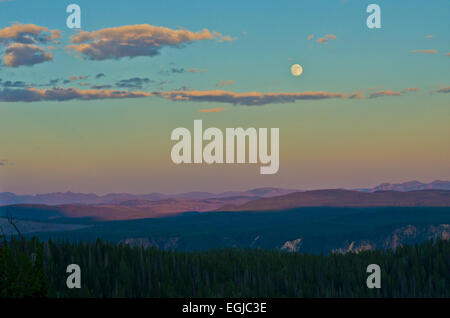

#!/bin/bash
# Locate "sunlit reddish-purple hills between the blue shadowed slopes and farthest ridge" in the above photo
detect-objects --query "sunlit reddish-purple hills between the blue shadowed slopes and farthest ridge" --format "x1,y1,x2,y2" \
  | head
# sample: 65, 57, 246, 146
0, 189, 450, 221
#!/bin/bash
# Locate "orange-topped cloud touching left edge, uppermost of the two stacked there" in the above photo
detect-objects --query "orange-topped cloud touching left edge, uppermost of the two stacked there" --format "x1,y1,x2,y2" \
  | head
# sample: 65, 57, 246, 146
0, 24, 61, 44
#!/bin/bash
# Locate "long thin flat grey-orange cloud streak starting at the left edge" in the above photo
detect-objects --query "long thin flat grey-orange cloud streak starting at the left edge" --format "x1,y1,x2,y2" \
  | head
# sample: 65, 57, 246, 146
0, 87, 152, 102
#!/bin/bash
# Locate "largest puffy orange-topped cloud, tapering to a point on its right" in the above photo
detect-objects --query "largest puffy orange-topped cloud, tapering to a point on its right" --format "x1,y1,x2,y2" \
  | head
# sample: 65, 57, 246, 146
67, 24, 233, 61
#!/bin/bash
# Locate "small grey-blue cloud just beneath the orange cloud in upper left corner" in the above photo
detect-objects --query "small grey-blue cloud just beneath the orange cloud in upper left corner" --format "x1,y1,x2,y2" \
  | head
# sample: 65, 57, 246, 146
4, 43, 53, 67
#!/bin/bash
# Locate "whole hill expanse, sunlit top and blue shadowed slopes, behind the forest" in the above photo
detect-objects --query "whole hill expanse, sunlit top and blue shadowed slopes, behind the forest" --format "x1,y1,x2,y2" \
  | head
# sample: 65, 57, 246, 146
0, 188, 450, 253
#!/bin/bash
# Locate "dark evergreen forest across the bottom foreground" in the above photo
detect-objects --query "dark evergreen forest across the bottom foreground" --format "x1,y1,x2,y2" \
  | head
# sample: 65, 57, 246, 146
0, 239, 450, 297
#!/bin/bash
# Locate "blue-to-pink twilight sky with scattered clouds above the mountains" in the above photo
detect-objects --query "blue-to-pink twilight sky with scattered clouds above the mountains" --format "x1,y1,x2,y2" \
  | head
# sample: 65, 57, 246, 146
0, 0, 450, 194
